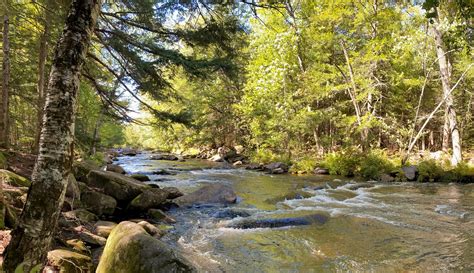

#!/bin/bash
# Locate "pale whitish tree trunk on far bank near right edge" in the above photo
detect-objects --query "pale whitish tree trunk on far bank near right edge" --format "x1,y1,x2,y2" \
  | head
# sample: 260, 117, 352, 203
433, 17, 462, 166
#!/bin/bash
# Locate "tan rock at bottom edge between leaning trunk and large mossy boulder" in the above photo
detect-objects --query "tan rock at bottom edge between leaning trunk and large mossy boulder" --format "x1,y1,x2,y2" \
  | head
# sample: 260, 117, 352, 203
47, 249, 92, 273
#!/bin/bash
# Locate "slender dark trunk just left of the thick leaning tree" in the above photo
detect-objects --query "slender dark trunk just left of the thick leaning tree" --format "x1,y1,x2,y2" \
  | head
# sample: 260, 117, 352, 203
33, 1, 52, 154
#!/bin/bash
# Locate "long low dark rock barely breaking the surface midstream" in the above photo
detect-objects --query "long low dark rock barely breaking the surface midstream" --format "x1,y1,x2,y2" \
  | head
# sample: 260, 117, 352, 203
227, 214, 329, 229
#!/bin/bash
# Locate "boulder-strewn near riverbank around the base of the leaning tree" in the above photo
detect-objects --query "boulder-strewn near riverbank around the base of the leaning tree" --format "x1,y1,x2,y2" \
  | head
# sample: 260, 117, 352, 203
0, 152, 237, 272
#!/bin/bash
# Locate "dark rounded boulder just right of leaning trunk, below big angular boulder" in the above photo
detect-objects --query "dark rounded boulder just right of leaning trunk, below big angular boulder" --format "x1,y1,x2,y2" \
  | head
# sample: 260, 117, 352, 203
81, 191, 117, 216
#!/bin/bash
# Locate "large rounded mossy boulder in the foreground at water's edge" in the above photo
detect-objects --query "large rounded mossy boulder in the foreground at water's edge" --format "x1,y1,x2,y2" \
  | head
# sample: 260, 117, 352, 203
96, 221, 196, 273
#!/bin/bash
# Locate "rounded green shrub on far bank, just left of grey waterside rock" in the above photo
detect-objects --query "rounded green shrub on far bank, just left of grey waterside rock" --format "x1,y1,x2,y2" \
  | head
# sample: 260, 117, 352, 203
359, 150, 395, 180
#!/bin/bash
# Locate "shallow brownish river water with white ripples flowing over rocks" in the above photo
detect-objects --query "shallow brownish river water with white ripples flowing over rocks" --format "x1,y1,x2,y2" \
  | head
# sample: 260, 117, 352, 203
118, 154, 474, 272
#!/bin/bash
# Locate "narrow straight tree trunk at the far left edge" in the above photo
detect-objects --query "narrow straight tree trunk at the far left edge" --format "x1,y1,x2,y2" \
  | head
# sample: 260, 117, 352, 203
0, 14, 10, 148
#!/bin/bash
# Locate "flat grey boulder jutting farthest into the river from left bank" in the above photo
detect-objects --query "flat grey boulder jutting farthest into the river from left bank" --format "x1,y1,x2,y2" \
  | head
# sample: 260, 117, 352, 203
174, 184, 237, 206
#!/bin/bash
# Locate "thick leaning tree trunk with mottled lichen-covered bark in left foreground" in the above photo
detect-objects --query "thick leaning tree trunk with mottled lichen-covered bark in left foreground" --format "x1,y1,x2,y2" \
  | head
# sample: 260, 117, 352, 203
3, 0, 100, 272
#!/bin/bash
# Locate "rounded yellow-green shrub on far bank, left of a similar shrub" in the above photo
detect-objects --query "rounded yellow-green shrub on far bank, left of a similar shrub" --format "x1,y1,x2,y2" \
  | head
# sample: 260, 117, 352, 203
322, 148, 361, 176
